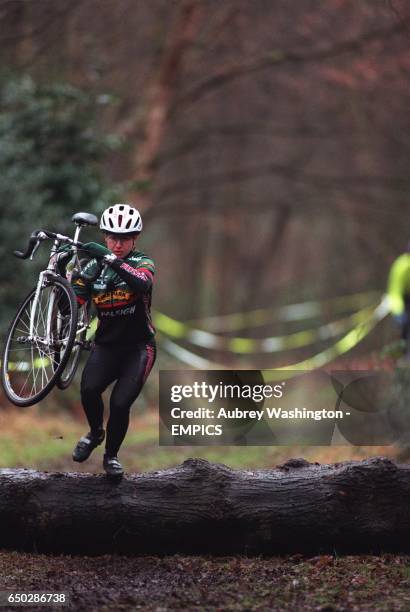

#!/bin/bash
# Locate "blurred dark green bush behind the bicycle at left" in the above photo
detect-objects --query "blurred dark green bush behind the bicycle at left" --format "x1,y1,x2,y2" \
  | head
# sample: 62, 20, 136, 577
0, 76, 119, 330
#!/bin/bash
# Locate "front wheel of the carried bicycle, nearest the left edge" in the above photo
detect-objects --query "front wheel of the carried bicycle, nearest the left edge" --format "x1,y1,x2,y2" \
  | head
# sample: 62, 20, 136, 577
1, 277, 78, 407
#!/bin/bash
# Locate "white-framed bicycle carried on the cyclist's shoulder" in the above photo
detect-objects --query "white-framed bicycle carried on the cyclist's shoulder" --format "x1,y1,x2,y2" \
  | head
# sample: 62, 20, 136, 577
1, 213, 103, 406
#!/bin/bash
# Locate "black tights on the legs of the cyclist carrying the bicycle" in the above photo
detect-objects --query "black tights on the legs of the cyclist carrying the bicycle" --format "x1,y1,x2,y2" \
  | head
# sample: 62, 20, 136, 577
81, 340, 156, 457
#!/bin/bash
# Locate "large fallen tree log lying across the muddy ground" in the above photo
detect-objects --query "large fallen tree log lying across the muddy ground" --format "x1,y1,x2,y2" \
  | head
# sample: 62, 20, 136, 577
0, 457, 410, 554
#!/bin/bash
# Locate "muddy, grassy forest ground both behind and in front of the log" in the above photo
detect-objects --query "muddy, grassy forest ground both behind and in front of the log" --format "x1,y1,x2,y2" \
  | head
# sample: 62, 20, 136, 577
0, 407, 410, 612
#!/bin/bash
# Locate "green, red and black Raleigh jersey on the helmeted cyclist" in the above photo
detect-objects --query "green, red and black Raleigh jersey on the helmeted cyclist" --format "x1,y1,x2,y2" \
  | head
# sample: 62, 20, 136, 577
73, 251, 155, 345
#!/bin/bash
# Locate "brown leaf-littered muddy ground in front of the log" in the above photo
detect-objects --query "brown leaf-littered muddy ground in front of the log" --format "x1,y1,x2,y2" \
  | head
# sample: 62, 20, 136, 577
0, 551, 410, 612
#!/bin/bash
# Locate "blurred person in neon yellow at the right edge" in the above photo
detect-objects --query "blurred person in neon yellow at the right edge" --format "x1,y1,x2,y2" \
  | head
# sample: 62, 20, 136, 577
387, 242, 410, 350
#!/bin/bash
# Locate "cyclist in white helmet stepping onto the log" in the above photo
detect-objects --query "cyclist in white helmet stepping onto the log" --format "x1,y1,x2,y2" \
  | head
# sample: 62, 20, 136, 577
73, 204, 156, 477
